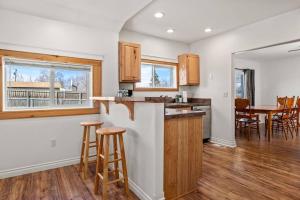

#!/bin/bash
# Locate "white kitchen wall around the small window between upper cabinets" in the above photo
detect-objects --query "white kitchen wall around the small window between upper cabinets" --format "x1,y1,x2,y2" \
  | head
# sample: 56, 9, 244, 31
119, 30, 190, 97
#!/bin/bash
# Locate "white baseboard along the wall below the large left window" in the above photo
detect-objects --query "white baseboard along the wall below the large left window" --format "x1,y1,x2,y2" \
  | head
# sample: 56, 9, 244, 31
0, 157, 80, 179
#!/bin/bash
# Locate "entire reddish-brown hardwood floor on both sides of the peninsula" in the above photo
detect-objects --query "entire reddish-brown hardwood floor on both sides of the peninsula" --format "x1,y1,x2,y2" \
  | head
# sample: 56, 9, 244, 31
0, 126, 300, 200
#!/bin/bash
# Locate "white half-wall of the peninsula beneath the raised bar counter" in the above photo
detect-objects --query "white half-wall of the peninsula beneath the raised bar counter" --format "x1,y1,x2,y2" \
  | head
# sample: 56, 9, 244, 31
92, 97, 164, 200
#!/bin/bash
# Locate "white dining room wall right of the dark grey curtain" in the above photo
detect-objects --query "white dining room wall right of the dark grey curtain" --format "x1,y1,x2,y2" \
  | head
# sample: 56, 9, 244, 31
261, 56, 300, 105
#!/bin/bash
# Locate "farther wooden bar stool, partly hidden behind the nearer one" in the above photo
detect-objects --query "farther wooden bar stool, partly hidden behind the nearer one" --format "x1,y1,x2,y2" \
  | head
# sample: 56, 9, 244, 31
79, 121, 103, 179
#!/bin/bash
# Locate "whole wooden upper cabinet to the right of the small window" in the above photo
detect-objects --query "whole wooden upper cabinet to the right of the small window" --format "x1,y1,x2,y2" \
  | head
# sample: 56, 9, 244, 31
178, 54, 200, 85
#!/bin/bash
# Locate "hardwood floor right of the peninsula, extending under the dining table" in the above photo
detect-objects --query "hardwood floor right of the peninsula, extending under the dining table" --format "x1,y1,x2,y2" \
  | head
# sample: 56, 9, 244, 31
182, 128, 300, 200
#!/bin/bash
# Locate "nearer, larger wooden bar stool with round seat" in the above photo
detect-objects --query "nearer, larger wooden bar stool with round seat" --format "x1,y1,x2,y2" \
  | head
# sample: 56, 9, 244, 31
95, 127, 129, 200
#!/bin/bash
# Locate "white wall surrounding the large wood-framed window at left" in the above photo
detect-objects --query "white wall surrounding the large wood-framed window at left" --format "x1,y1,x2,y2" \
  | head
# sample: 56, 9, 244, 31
0, 9, 119, 178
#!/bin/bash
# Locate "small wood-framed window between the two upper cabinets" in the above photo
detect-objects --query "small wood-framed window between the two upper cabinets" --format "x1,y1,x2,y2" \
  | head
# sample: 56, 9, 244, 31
135, 60, 178, 91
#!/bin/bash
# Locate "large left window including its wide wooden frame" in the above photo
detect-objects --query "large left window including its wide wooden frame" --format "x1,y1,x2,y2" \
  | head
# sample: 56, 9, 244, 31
0, 50, 101, 119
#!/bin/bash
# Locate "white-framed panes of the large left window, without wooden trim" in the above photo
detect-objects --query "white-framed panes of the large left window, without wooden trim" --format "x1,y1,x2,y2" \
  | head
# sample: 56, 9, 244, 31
3, 57, 92, 111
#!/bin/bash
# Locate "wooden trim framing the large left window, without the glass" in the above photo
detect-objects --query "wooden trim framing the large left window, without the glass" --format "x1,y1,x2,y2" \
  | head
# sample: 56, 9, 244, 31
0, 49, 102, 120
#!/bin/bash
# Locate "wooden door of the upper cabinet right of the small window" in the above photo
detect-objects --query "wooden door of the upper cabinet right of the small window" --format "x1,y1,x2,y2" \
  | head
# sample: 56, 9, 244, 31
187, 55, 200, 85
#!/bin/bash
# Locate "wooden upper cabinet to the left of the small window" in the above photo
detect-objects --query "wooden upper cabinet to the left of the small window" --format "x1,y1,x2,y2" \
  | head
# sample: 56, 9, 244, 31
119, 42, 141, 82
